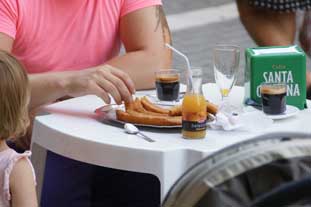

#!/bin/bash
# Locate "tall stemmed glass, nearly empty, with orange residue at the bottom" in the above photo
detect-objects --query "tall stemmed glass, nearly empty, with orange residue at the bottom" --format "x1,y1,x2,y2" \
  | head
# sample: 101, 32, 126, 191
213, 45, 240, 112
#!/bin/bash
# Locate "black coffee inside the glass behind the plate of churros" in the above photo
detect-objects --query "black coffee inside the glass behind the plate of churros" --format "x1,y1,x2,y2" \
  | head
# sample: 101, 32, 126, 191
156, 79, 179, 101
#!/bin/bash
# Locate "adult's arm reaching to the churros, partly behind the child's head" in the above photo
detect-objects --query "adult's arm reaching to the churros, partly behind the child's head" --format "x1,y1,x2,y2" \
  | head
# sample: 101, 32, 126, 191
0, 33, 135, 110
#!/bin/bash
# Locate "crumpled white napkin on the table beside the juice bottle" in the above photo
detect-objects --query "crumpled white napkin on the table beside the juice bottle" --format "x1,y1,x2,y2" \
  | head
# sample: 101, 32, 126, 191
209, 111, 243, 131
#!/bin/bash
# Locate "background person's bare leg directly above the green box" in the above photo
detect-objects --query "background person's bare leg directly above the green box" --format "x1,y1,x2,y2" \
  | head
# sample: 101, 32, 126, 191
237, 0, 296, 46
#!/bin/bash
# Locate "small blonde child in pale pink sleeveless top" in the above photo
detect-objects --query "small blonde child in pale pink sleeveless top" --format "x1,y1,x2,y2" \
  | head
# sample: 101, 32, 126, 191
0, 51, 37, 207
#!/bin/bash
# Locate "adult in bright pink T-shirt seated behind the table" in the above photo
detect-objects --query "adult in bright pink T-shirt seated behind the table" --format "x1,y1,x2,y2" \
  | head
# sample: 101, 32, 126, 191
0, 0, 171, 207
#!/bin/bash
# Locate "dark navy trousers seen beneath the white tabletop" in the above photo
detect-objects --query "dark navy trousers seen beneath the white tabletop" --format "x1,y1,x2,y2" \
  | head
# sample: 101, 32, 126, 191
40, 152, 160, 207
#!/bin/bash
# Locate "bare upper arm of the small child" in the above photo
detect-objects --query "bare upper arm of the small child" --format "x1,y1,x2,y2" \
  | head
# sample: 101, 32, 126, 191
10, 158, 38, 207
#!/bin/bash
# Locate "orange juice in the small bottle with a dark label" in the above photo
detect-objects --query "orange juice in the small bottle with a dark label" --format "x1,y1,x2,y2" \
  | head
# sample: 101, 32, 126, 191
182, 93, 207, 139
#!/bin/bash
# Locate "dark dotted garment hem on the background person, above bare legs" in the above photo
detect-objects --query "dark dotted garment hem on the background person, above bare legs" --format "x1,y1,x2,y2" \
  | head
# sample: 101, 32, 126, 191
248, 0, 311, 12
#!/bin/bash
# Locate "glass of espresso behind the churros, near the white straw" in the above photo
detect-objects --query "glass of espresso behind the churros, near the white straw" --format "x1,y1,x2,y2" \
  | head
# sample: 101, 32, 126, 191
155, 70, 180, 101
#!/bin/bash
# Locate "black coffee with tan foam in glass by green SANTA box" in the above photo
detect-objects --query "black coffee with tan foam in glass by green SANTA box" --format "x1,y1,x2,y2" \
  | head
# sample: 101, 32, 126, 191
261, 85, 286, 115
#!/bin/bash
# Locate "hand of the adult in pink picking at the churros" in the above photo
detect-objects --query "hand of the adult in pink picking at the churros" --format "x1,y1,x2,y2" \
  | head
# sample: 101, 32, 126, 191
63, 65, 135, 104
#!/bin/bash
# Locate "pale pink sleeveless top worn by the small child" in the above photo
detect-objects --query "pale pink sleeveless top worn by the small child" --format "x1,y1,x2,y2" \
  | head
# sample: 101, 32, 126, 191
0, 149, 35, 207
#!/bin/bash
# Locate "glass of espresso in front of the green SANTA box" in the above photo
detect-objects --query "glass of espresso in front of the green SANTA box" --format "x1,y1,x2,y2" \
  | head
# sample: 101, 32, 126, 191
260, 83, 287, 115
